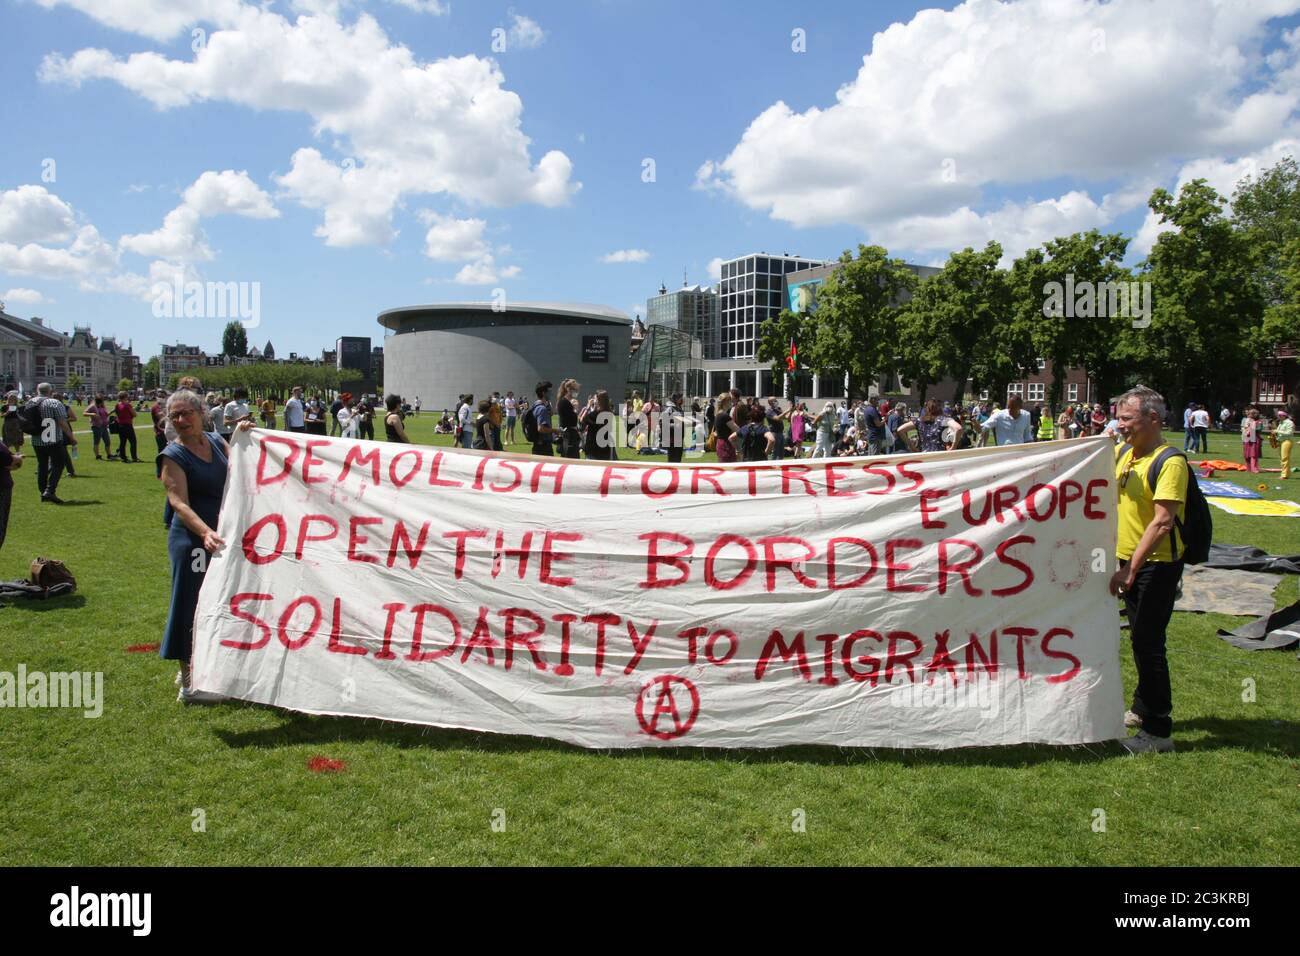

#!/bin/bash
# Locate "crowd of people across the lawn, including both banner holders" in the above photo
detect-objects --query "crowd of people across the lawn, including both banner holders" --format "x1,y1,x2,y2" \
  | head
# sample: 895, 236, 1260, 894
0, 377, 1294, 750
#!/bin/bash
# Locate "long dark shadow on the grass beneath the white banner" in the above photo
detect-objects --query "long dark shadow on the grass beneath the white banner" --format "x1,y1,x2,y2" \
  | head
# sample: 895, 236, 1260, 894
215, 704, 1144, 767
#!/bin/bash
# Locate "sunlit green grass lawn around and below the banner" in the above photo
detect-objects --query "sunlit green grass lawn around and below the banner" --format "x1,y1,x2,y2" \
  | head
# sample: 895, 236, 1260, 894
0, 421, 1300, 865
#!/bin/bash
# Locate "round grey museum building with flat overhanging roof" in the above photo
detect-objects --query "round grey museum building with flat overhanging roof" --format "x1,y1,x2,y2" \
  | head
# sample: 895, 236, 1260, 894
378, 302, 632, 410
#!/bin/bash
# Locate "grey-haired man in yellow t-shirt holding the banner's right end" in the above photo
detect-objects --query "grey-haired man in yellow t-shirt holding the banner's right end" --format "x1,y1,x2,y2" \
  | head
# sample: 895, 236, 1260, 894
1110, 385, 1191, 753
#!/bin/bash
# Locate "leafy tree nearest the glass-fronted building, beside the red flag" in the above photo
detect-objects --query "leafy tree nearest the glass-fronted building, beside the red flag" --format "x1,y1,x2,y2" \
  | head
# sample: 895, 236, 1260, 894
800, 245, 919, 394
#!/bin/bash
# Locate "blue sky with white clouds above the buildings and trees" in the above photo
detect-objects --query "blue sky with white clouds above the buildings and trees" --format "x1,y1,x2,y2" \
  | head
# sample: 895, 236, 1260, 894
0, 0, 1300, 356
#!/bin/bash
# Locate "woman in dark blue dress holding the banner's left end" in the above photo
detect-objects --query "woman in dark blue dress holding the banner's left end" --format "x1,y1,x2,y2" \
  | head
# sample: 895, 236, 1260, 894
157, 390, 251, 704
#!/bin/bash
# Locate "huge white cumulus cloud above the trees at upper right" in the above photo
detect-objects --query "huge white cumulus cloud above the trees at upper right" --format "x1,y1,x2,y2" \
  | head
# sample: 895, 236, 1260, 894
696, 0, 1300, 256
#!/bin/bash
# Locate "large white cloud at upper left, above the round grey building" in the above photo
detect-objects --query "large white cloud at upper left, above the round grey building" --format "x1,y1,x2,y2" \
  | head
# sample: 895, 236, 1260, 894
40, 3, 581, 246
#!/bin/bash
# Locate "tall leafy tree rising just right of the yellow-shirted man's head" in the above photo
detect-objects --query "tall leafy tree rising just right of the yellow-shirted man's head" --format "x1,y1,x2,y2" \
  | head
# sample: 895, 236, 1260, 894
1118, 179, 1264, 407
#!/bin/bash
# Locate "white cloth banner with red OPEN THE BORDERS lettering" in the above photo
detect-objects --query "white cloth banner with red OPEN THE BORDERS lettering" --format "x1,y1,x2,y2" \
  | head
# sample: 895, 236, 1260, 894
192, 429, 1123, 748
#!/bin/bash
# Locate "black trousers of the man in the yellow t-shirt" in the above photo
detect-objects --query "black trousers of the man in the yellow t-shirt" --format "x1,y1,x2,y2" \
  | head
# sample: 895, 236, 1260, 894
1121, 556, 1183, 737
